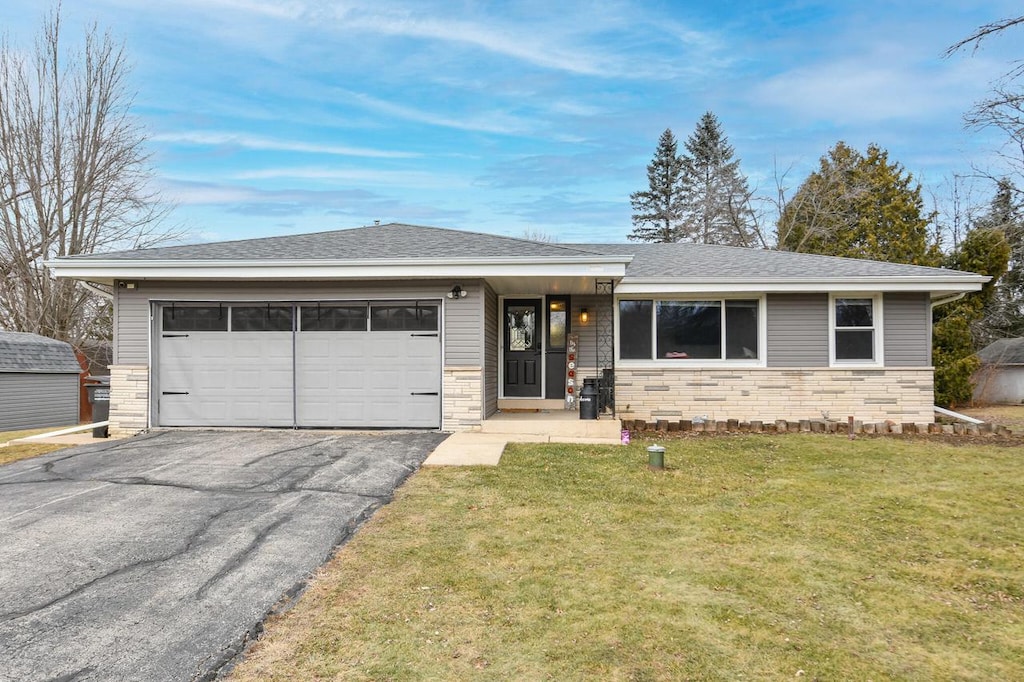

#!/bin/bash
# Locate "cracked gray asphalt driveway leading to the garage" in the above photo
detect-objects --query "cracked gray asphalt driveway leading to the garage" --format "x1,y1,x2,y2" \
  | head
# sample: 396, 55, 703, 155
0, 431, 444, 682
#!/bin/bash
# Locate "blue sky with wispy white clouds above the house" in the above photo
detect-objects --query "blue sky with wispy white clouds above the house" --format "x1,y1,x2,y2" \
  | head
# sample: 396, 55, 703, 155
0, 0, 1024, 242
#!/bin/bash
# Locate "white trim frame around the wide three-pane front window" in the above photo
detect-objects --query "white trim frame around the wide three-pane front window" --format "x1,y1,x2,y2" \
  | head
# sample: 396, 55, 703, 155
614, 293, 768, 369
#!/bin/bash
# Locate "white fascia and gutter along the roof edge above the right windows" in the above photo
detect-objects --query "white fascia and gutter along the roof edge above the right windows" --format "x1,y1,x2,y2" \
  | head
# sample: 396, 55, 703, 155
615, 275, 988, 294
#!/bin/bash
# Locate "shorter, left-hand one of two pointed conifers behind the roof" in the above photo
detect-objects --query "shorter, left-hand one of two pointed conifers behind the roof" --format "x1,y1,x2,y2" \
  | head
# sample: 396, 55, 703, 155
629, 128, 682, 242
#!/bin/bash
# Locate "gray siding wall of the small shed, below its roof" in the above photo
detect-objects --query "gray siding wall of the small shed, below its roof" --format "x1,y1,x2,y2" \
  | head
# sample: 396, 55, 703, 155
0, 372, 79, 431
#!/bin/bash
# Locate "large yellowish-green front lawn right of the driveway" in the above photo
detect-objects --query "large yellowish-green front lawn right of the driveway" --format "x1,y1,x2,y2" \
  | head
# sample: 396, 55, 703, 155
232, 435, 1024, 680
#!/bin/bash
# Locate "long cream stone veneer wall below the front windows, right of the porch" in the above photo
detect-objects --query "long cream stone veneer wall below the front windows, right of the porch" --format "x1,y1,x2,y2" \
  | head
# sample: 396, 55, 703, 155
615, 367, 935, 423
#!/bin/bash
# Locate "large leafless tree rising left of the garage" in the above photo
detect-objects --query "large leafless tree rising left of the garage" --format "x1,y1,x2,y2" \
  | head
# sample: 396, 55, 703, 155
0, 7, 177, 342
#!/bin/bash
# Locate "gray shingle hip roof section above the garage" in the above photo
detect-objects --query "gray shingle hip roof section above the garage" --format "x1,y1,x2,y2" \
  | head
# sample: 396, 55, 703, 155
76, 223, 588, 261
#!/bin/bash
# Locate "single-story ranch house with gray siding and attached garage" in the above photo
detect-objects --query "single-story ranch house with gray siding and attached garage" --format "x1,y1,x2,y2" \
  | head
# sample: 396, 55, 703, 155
48, 224, 986, 433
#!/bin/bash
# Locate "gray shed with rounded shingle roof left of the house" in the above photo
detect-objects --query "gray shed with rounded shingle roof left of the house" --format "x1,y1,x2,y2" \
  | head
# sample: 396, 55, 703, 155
0, 332, 82, 431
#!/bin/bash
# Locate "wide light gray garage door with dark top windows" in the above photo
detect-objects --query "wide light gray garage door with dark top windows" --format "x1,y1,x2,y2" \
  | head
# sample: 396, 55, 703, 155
157, 302, 441, 428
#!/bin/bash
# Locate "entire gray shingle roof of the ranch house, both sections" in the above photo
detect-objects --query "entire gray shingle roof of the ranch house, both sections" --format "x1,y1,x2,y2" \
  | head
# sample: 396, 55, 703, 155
63, 223, 972, 281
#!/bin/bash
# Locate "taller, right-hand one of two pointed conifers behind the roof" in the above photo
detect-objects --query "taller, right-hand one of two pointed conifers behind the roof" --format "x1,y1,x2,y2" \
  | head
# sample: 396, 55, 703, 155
678, 112, 756, 246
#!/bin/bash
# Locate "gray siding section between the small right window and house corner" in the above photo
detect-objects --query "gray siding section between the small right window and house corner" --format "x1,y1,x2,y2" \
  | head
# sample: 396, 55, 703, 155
882, 292, 932, 367
